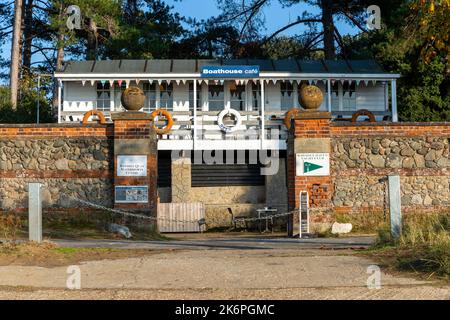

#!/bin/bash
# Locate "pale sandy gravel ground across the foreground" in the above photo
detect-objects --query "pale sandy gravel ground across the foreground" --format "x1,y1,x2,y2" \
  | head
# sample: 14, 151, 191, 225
0, 249, 450, 300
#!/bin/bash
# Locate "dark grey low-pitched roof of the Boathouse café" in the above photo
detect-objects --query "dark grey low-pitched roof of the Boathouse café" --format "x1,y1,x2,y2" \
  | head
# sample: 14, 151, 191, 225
63, 59, 386, 74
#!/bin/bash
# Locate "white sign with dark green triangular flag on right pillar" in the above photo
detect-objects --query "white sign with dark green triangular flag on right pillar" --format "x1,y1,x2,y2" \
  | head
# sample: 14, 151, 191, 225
296, 153, 330, 176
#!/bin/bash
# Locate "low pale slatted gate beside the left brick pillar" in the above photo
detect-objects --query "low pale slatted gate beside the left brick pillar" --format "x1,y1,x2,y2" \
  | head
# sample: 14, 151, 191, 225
158, 203, 205, 233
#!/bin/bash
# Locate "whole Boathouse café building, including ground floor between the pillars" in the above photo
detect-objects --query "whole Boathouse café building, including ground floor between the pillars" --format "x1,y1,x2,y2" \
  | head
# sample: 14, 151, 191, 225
55, 59, 399, 225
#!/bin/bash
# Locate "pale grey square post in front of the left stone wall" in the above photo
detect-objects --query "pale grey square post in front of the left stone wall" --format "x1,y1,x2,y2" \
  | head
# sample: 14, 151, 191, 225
28, 183, 42, 242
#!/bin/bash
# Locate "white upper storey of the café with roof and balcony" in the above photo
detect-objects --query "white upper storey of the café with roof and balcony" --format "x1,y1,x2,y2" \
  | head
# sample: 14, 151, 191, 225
55, 59, 399, 150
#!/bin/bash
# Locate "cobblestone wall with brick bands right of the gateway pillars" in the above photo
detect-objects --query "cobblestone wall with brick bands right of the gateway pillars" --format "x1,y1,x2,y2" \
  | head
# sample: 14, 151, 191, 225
331, 123, 450, 212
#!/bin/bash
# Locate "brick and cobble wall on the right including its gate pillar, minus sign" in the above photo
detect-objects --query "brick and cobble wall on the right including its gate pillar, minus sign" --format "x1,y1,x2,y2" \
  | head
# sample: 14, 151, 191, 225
288, 115, 450, 222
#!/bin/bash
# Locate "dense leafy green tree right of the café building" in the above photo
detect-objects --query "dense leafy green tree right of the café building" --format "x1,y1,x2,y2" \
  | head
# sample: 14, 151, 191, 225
344, 1, 450, 121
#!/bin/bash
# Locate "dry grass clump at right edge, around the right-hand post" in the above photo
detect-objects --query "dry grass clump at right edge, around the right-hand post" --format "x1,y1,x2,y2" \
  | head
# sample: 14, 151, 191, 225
369, 213, 450, 280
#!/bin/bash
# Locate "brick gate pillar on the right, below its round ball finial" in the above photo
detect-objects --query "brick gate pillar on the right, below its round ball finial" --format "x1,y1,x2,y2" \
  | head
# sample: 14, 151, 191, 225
287, 111, 332, 236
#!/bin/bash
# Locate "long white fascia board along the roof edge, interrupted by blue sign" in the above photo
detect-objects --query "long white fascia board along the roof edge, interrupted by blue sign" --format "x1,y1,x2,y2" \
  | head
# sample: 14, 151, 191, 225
54, 72, 400, 81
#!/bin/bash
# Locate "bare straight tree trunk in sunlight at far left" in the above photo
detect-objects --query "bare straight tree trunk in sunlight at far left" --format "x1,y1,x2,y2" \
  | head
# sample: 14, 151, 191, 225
10, 0, 22, 109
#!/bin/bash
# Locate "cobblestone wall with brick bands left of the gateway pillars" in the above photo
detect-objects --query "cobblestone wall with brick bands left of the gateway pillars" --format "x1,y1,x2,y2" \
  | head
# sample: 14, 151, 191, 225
0, 124, 113, 210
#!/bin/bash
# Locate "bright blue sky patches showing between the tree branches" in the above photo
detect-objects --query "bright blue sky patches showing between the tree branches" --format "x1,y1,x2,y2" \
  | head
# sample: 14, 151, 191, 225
2, 0, 358, 84
